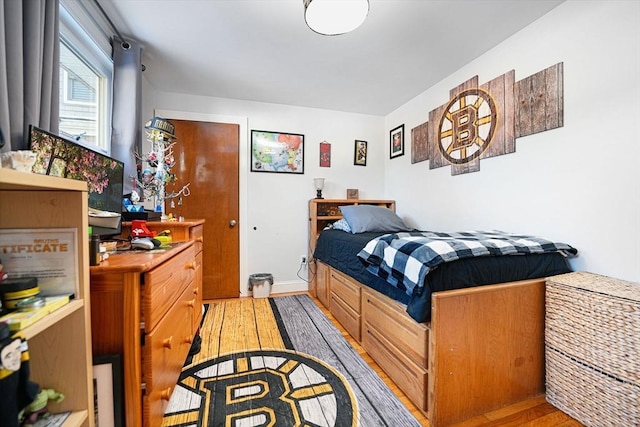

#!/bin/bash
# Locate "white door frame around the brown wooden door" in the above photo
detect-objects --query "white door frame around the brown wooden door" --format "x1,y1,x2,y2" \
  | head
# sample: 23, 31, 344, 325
154, 109, 249, 297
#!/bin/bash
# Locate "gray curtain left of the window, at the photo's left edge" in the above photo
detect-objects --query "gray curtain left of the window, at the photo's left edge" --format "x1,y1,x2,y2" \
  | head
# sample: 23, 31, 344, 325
0, 0, 60, 152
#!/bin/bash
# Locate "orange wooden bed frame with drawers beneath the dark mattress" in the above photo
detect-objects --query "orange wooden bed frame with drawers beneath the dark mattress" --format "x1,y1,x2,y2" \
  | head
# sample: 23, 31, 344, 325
310, 200, 545, 427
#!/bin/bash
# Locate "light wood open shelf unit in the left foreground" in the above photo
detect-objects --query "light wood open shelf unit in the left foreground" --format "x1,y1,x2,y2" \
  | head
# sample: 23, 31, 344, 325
0, 169, 94, 427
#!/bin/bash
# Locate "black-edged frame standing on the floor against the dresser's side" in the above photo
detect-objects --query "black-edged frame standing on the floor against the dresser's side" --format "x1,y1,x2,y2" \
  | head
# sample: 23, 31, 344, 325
93, 354, 124, 427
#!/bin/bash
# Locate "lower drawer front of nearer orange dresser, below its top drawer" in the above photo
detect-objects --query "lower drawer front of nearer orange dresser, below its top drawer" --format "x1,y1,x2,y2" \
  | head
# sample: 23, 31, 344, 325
142, 286, 194, 426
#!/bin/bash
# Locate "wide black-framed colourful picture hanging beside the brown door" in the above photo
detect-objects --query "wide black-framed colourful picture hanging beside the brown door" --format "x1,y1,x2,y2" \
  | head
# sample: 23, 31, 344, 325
250, 130, 304, 174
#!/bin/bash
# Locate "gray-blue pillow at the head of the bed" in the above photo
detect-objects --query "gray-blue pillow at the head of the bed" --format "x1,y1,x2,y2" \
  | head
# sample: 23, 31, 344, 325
340, 205, 411, 233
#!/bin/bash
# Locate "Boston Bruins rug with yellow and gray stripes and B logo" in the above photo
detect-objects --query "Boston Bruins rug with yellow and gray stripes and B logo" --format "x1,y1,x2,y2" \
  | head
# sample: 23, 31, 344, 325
162, 295, 420, 427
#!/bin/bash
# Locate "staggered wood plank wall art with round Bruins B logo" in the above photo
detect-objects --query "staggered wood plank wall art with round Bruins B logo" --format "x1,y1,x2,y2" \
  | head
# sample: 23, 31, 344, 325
420, 63, 564, 175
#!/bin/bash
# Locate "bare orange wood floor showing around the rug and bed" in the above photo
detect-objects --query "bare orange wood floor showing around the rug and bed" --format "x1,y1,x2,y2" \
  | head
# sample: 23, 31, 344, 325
205, 294, 582, 427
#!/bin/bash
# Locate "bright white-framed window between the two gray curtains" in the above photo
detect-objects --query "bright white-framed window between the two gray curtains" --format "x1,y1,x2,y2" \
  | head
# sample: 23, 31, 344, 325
59, 5, 113, 155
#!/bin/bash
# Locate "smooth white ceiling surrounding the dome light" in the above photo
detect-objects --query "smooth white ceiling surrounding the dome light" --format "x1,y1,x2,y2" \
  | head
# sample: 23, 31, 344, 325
99, 0, 564, 115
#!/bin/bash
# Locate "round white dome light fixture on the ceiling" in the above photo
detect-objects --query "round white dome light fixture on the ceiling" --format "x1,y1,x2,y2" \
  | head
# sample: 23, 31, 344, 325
302, 0, 369, 36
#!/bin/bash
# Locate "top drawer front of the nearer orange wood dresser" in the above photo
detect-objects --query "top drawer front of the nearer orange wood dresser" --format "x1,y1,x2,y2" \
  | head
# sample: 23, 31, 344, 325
142, 246, 197, 332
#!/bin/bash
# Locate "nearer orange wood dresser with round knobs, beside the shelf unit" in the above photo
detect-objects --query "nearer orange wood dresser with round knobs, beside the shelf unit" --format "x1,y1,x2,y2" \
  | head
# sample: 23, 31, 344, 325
90, 240, 202, 427
